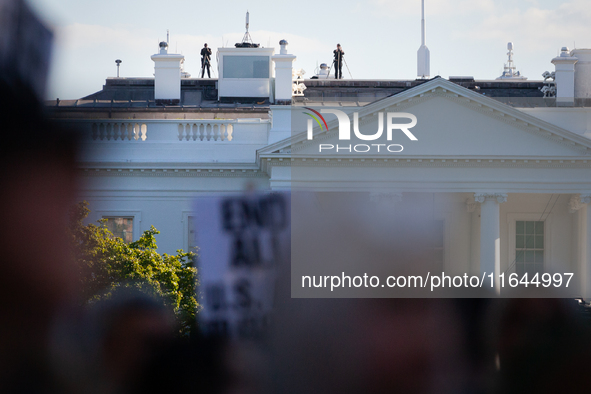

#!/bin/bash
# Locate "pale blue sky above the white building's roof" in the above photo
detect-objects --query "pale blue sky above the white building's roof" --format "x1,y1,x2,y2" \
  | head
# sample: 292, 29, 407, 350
29, 0, 591, 99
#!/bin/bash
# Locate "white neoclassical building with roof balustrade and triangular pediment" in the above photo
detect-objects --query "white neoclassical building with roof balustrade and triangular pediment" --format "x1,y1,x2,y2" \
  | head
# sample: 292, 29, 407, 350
49, 43, 591, 296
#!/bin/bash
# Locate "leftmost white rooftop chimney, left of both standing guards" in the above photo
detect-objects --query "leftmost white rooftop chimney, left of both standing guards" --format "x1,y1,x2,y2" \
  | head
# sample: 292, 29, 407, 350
152, 41, 185, 104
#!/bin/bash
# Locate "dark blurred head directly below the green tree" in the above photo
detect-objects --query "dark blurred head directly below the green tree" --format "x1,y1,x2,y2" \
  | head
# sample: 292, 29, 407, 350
50, 288, 176, 394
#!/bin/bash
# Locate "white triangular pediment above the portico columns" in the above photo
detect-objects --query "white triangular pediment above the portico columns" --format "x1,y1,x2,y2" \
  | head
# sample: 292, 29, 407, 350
258, 78, 591, 159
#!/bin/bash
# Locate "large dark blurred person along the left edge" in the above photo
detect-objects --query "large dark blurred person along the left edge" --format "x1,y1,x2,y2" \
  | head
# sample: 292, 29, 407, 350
0, 78, 78, 387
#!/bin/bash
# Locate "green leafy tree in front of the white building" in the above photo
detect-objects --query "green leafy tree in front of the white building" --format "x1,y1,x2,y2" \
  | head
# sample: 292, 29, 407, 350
69, 201, 199, 335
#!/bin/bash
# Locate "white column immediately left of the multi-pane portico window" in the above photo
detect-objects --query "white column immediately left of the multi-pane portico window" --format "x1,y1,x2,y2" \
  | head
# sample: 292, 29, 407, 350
474, 193, 507, 293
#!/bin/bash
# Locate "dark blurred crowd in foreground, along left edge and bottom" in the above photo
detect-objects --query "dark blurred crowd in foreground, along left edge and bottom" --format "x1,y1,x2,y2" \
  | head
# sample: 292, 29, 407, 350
0, 63, 591, 394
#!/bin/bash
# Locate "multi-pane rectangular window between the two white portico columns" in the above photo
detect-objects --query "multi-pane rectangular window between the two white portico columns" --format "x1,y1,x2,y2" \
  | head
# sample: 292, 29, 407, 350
515, 220, 544, 275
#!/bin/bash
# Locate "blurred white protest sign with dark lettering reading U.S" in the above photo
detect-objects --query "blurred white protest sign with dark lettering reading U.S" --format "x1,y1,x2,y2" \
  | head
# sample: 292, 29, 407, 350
193, 193, 290, 338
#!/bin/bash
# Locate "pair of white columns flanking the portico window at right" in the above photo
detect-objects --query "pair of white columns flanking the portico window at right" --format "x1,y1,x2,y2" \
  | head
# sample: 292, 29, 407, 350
474, 193, 591, 299
